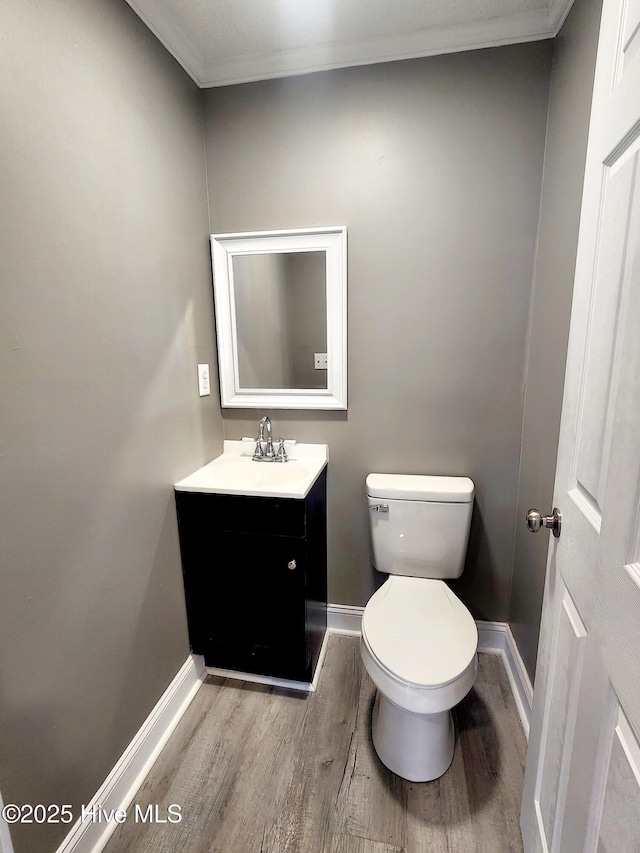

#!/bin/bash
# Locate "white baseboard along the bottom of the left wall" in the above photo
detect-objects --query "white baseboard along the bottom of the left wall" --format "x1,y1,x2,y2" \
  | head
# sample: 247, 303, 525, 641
57, 655, 205, 853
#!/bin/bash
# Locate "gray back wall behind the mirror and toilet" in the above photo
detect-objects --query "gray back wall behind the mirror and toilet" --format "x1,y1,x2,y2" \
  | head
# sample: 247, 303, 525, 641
205, 43, 551, 619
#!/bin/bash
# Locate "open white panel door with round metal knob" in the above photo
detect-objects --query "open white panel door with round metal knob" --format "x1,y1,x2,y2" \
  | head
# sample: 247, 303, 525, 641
522, 0, 640, 853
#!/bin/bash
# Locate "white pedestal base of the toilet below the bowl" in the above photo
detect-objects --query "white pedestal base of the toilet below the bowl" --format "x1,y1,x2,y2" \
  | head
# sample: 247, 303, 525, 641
371, 690, 455, 782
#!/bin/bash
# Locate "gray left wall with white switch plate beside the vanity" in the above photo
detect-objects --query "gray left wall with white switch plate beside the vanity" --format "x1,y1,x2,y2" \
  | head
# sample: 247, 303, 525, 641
0, 0, 222, 853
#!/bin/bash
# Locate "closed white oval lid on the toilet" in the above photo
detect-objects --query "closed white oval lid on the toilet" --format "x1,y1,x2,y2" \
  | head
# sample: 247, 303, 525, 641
362, 576, 478, 687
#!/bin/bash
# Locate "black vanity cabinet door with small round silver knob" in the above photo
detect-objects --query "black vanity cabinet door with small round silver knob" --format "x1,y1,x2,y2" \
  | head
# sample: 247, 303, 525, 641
201, 531, 308, 680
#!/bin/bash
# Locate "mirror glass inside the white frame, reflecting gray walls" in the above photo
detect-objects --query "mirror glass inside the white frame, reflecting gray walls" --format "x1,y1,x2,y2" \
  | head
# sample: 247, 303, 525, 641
233, 251, 327, 389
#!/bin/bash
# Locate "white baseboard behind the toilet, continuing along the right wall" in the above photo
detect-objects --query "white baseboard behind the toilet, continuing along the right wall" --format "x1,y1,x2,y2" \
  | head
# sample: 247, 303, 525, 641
327, 604, 533, 738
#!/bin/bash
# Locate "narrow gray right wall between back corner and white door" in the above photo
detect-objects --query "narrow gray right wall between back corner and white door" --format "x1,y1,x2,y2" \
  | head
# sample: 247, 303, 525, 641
509, 0, 602, 678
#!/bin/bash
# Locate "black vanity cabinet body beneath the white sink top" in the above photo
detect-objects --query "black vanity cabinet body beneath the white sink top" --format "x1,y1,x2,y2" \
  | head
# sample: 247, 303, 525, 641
175, 468, 327, 682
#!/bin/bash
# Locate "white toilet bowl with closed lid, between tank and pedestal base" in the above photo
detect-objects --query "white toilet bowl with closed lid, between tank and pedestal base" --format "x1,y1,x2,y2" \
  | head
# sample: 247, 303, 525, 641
361, 575, 478, 714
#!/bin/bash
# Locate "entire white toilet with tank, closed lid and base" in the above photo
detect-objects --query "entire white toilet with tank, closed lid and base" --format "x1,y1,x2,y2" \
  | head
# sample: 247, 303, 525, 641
360, 474, 478, 782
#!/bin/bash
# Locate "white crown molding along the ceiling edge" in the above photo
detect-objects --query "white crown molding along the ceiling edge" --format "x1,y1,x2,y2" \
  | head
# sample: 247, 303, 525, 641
127, 0, 574, 88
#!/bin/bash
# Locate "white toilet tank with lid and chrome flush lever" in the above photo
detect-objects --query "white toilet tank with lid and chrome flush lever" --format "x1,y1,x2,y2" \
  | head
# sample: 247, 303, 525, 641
367, 474, 474, 578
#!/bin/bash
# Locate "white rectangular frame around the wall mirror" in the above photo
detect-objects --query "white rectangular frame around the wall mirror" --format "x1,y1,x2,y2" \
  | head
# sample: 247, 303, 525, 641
211, 226, 347, 409
